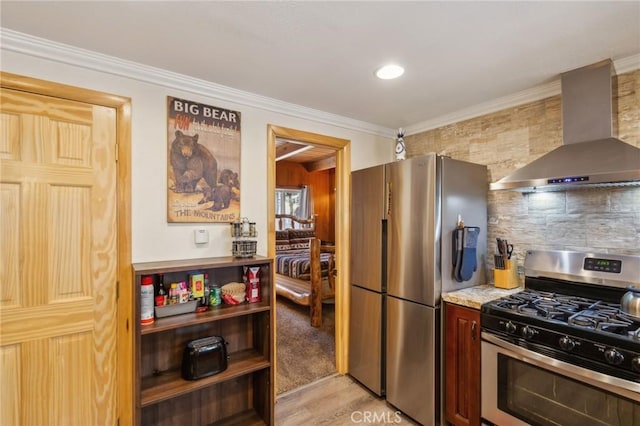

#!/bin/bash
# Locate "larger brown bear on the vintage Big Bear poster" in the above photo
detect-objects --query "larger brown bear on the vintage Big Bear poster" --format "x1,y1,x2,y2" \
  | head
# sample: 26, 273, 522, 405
170, 130, 218, 192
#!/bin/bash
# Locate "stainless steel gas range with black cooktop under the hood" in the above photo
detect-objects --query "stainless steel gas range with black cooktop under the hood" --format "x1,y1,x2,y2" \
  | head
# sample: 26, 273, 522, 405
481, 251, 640, 426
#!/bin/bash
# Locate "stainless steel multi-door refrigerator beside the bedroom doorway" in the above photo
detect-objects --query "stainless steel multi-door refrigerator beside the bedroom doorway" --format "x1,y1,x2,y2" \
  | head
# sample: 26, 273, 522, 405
349, 154, 488, 425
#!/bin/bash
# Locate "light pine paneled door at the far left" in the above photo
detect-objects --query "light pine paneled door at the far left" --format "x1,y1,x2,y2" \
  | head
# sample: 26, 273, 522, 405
0, 89, 118, 425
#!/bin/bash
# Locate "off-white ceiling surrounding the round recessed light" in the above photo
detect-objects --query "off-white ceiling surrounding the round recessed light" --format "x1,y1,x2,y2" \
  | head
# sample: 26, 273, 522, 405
0, 0, 640, 129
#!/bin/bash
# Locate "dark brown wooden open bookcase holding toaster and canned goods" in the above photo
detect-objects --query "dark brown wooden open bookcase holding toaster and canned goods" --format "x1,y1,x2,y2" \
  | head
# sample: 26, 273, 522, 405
133, 256, 274, 425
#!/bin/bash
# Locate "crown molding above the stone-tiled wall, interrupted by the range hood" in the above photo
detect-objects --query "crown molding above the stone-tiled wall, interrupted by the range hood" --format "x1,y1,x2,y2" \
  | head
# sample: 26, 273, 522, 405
405, 54, 640, 135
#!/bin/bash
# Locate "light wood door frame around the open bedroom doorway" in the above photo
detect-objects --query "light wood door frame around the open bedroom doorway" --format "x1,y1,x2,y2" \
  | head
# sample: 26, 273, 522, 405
267, 125, 351, 386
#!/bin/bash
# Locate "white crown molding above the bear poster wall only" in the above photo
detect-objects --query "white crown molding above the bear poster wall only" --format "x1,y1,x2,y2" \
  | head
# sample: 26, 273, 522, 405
0, 28, 394, 137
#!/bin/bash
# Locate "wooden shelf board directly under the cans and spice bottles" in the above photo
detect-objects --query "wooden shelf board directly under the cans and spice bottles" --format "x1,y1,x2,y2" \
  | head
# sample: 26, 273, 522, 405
140, 298, 271, 335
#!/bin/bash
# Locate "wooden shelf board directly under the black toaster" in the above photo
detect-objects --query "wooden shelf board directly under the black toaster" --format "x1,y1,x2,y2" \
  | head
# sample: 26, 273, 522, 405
140, 350, 271, 407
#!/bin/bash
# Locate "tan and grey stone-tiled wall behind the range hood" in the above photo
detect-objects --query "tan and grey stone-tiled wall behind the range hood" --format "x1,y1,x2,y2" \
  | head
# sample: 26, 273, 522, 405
404, 70, 640, 272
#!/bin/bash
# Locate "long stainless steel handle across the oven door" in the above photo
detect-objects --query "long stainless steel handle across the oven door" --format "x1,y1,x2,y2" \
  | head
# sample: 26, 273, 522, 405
481, 331, 640, 401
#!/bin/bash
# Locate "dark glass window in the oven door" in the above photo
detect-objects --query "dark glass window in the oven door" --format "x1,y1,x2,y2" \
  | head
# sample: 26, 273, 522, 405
498, 354, 640, 426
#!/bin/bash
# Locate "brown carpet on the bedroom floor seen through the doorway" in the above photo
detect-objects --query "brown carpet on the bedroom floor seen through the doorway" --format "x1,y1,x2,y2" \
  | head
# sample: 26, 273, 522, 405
276, 298, 336, 394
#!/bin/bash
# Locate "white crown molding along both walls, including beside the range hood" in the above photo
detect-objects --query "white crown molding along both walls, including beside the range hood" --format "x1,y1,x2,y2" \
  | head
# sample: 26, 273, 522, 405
0, 27, 640, 138
